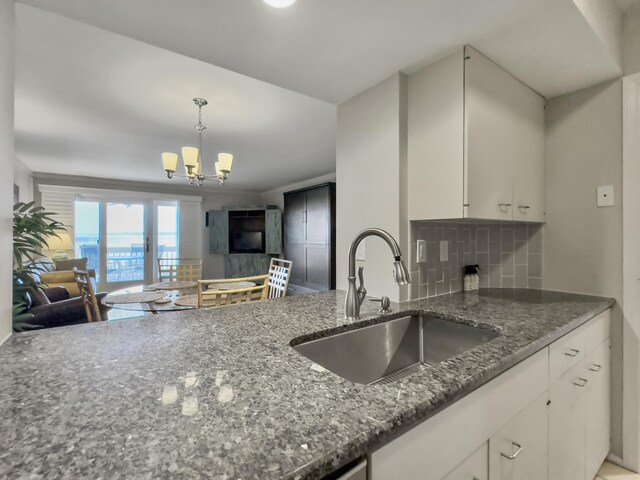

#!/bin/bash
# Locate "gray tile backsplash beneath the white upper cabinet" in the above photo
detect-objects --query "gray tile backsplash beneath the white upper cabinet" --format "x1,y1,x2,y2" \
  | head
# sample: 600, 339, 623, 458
411, 222, 542, 299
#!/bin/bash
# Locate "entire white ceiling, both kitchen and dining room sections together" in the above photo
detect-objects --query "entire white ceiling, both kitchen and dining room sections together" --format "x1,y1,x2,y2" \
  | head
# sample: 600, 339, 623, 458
16, 0, 624, 191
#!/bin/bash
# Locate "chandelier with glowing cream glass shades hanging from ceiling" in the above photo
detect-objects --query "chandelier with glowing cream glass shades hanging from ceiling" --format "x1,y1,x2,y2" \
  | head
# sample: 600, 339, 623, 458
162, 98, 233, 185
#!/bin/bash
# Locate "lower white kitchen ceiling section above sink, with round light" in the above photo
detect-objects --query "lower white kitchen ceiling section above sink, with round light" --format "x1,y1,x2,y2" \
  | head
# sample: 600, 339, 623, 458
22, 0, 621, 104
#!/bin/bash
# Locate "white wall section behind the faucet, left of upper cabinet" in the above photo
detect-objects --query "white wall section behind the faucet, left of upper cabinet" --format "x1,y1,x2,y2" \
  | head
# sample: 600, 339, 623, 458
336, 73, 409, 300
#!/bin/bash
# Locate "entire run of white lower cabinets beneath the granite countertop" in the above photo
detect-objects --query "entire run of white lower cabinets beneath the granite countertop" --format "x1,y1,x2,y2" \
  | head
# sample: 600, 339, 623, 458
369, 310, 610, 480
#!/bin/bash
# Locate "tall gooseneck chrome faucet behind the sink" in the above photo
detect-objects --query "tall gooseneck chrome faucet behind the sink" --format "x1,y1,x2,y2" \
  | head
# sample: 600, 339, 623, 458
344, 228, 411, 320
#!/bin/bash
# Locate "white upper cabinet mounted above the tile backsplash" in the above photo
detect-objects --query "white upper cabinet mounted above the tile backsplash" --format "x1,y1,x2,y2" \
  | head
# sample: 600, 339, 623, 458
407, 47, 544, 222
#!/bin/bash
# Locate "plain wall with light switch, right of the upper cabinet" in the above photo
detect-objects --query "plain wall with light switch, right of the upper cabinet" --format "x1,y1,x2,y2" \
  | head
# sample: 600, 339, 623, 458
543, 81, 622, 455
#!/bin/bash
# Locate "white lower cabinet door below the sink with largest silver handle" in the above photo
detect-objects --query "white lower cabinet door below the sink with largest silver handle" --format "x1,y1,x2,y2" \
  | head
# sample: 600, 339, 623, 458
489, 392, 548, 480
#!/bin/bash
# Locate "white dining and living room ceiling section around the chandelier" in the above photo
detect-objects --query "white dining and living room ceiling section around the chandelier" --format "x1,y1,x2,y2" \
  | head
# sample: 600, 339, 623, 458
15, 5, 336, 191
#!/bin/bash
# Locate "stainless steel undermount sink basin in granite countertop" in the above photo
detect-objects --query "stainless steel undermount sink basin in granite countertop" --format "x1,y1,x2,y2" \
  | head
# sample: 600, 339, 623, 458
293, 316, 499, 384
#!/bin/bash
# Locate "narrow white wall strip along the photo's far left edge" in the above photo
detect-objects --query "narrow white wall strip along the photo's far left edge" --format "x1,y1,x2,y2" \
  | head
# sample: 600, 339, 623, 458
0, 0, 15, 343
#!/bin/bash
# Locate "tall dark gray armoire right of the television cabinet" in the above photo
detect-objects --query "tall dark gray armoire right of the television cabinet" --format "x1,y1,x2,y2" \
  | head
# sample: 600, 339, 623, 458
283, 183, 336, 295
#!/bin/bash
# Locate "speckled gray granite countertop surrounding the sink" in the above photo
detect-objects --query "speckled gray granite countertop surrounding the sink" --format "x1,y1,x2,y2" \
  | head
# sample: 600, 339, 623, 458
0, 289, 614, 480
